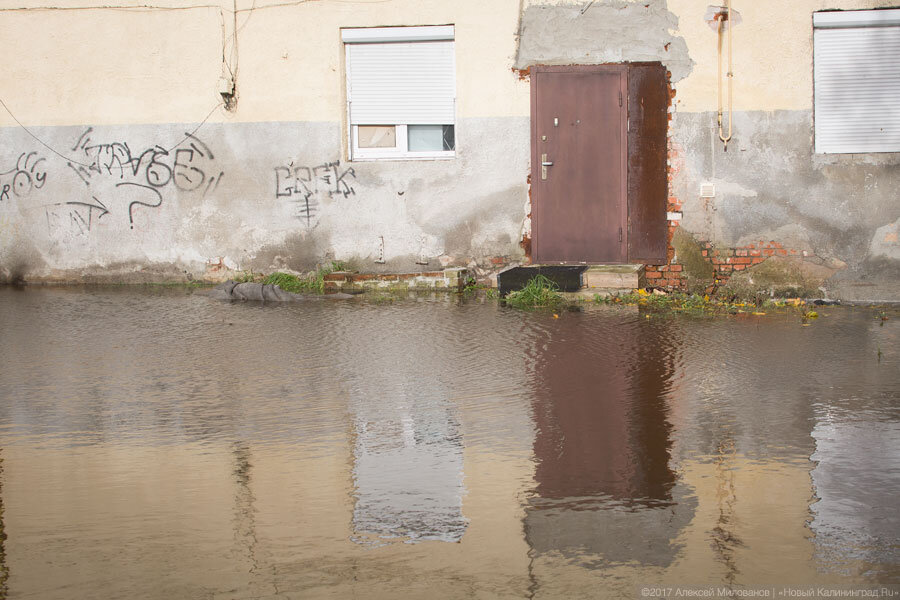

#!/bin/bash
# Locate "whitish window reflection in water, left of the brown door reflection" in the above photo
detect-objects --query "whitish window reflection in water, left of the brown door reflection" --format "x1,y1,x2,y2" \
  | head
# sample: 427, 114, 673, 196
353, 397, 466, 542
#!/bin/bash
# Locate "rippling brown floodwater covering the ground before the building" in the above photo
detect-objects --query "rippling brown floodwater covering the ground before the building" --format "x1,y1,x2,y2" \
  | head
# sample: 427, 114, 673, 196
0, 288, 900, 599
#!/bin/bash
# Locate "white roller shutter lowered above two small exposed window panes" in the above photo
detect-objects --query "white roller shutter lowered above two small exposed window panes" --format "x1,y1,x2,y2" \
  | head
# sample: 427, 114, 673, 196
346, 35, 456, 125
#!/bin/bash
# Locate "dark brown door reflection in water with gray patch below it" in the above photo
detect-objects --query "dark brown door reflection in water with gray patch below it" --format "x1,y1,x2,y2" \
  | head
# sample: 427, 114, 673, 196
525, 317, 696, 565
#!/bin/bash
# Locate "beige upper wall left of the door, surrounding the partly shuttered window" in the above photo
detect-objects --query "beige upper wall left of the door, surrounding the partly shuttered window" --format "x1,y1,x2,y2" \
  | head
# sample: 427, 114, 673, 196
0, 0, 529, 126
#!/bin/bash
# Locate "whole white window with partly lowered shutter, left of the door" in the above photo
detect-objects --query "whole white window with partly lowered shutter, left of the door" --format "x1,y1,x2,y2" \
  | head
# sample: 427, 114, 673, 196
341, 25, 456, 160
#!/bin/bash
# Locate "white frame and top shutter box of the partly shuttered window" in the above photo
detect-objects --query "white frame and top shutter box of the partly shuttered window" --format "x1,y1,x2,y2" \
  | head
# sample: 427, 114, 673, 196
341, 25, 459, 162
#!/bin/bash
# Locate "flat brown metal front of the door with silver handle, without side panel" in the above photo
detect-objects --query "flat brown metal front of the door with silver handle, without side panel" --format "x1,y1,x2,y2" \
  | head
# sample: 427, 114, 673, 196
531, 65, 628, 264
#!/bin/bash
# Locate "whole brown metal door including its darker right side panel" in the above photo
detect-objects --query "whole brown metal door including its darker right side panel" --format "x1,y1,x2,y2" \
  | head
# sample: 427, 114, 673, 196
531, 63, 669, 264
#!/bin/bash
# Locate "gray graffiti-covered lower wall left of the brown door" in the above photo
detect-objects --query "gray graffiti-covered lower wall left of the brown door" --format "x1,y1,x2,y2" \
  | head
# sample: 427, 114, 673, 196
0, 118, 529, 281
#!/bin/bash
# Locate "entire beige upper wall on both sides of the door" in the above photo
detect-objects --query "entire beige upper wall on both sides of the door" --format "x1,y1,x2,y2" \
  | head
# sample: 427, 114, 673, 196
0, 0, 893, 126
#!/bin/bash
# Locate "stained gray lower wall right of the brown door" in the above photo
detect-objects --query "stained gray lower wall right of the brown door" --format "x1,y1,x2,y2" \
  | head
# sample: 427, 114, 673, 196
671, 111, 900, 300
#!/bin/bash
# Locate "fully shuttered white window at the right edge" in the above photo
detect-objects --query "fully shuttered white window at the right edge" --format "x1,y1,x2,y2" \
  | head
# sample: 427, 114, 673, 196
813, 9, 900, 153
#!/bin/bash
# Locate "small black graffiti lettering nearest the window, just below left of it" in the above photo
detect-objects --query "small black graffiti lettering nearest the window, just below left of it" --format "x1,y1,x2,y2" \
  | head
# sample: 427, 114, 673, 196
275, 160, 356, 227
